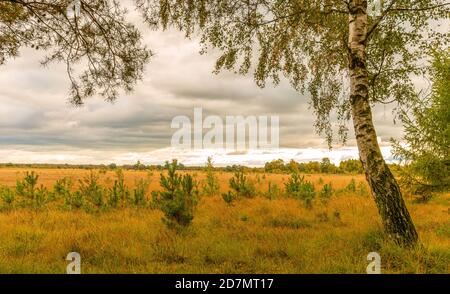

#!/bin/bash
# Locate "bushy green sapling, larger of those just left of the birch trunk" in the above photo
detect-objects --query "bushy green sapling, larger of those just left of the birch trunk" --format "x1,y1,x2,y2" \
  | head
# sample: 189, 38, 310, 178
285, 173, 316, 208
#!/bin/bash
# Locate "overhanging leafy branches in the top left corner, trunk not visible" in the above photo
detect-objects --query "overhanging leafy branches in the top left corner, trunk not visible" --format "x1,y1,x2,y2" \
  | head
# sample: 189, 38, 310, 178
0, 0, 151, 105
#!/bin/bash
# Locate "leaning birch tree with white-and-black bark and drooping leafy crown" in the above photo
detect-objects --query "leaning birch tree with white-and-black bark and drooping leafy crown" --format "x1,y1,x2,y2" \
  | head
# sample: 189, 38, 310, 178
136, 0, 449, 246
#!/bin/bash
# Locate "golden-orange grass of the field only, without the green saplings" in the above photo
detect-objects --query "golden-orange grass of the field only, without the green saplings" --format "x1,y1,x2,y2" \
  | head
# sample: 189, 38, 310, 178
0, 168, 450, 274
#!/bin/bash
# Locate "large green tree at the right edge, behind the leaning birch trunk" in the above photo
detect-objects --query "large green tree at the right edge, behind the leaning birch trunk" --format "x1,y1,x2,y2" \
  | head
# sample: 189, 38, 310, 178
394, 50, 450, 195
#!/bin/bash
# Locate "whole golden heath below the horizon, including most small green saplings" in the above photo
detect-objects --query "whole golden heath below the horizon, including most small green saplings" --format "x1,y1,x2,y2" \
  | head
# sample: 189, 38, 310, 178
0, 167, 450, 273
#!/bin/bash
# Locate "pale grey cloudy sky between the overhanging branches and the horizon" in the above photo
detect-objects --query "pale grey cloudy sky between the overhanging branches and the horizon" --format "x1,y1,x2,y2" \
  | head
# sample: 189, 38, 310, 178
0, 3, 414, 165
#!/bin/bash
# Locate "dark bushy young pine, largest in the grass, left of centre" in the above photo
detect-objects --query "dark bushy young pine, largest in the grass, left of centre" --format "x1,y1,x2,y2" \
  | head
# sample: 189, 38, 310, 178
153, 160, 198, 229
